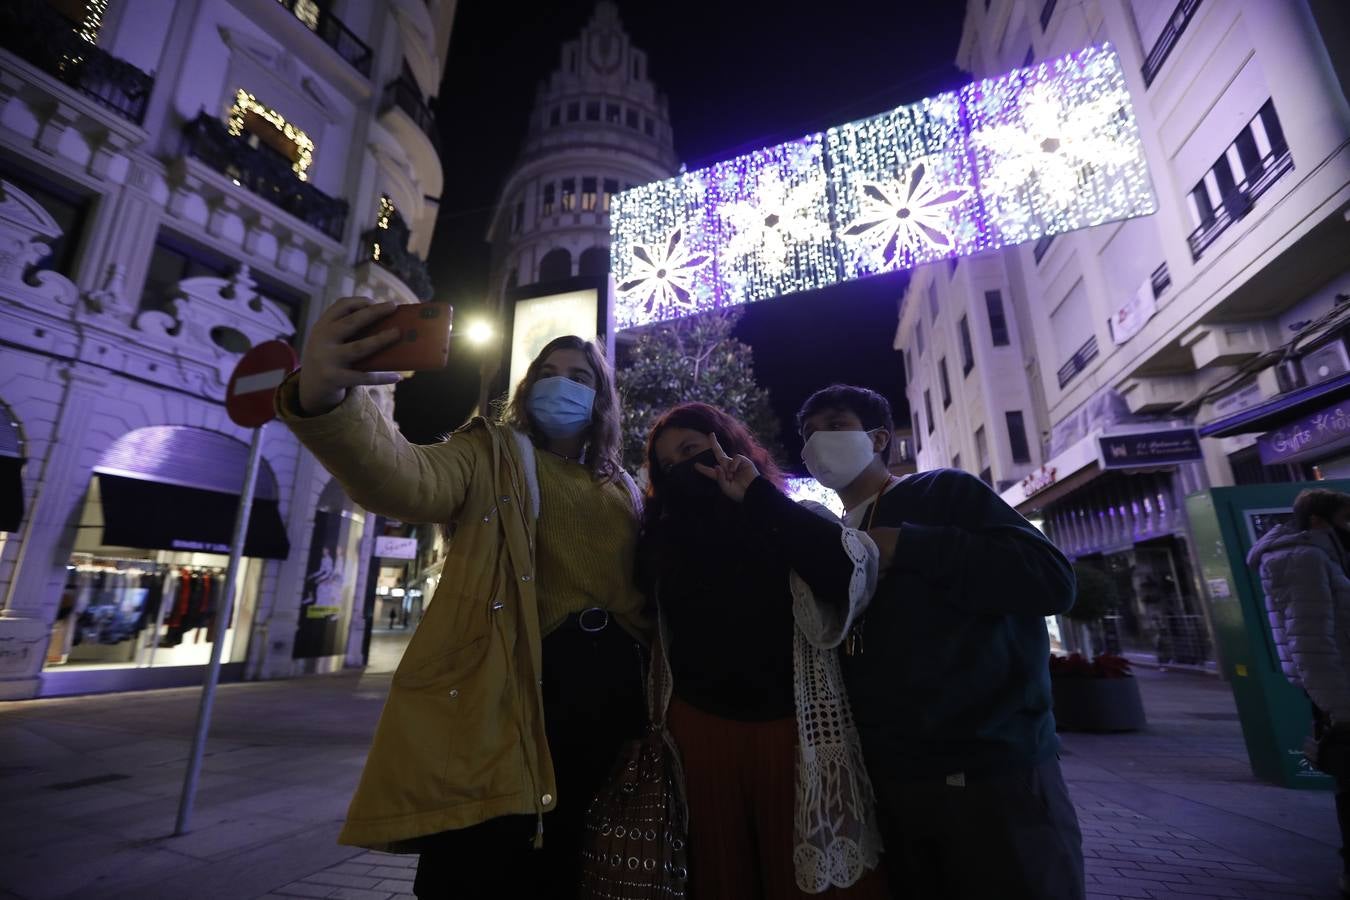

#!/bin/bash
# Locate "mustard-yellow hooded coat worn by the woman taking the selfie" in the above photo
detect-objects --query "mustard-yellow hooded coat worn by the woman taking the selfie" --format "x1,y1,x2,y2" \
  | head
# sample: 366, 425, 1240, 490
277, 376, 583, 851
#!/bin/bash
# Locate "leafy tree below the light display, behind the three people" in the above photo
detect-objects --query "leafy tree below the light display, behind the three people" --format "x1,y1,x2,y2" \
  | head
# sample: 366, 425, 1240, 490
618, 310, 779, 472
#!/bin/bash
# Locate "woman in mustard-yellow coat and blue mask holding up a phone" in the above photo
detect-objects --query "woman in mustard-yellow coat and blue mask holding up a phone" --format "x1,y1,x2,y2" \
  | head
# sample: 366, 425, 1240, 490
277, 297, 648, 899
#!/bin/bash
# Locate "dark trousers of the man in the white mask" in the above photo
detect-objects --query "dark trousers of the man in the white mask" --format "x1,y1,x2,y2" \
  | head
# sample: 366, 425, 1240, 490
872, 760, 1084, 900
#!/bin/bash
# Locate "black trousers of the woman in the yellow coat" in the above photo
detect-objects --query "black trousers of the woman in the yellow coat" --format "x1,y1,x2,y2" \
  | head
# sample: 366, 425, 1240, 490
413, 617, 647, 900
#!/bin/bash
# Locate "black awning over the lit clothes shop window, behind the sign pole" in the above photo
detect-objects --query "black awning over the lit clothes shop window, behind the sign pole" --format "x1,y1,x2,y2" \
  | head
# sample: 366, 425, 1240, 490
99, 472, 290, 560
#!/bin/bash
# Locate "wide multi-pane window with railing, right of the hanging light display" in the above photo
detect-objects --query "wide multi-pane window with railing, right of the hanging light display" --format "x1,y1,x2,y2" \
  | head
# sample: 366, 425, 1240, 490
1187, 100, 1293, 259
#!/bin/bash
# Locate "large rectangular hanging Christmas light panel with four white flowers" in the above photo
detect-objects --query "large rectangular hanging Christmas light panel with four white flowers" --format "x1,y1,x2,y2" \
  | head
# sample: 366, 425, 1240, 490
610, 45, 1156, 329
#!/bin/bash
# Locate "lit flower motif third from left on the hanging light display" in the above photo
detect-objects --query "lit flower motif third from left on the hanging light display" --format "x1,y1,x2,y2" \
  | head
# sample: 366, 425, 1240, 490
844, 162, 971, 266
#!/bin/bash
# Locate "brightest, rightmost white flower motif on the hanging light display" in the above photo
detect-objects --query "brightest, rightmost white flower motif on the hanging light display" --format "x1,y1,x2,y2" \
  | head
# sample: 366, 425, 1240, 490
971, 82, 1138, 208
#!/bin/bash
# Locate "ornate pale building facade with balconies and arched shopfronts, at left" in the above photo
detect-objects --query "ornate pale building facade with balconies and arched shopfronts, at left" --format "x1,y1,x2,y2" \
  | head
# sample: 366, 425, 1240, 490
0, 0, 455, 698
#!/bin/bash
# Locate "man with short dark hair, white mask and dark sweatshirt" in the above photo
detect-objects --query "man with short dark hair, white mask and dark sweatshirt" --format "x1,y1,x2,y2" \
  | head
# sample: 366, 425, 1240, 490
798, 385, 1084, 900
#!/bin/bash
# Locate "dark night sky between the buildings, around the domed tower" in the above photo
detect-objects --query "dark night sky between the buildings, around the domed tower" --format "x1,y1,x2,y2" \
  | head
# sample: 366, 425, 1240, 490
398, 0, 967, 464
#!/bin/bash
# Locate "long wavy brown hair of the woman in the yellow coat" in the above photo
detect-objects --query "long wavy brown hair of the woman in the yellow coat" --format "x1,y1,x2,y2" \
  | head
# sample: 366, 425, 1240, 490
500, 335, 622, 482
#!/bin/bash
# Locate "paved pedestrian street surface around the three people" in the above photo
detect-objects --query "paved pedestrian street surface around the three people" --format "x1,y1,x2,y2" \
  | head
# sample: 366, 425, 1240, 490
0, 630, 1339, 900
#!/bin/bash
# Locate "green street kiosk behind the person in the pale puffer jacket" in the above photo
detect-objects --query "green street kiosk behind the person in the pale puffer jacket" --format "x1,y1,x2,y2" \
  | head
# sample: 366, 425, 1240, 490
1185, 480, 1350, 791
